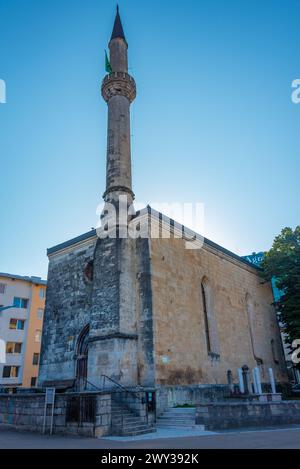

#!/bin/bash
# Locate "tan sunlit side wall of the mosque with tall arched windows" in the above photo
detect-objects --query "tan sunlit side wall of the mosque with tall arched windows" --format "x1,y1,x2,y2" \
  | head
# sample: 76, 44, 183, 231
151, 239, 287, 386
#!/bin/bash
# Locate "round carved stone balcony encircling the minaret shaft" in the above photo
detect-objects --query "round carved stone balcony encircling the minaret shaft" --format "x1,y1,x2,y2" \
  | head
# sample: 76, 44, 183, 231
101, 72, 136, 103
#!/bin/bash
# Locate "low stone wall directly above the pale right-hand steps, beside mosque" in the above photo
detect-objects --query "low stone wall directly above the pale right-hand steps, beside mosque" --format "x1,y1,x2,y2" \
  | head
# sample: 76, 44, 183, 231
156, 384, 230, 416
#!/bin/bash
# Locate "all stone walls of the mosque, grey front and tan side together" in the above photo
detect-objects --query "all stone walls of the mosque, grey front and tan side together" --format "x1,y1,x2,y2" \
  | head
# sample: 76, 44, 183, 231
39, 209, 287, 387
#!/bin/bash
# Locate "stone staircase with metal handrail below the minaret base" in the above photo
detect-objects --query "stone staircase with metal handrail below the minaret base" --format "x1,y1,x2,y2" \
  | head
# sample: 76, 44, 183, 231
111, 400, 156, 436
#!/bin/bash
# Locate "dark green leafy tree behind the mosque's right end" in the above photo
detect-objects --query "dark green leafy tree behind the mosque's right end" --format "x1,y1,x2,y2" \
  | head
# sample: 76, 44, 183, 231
261, 226, 300, 364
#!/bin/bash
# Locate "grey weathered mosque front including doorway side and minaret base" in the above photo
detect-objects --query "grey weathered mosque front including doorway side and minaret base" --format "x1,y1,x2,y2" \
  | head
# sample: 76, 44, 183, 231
39, 228, 155, 388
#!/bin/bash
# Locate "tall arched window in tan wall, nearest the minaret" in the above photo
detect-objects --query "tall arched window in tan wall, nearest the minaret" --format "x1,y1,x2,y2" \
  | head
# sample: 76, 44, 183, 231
201, 277, 220, 357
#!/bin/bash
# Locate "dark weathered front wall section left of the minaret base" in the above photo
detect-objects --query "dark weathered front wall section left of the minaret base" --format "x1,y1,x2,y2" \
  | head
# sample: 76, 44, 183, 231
39, 239, 95, 385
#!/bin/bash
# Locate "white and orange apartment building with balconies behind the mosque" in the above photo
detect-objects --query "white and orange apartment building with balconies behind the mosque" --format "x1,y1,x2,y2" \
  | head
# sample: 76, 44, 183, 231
0, 273, 47, 389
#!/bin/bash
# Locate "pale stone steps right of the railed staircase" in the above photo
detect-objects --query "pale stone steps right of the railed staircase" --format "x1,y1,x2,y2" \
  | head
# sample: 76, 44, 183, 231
156, 407, 204, 431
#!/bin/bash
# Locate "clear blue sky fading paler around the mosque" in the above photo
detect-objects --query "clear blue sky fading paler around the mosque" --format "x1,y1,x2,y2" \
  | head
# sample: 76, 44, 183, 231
0, 0, 300, 277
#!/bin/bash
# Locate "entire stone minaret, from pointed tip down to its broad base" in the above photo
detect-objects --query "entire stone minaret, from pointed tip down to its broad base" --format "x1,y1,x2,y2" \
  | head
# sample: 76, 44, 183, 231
88, 9, 141, 386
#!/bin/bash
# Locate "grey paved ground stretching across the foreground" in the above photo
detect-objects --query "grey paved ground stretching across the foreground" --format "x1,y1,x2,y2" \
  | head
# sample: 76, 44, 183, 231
0, 426, 300, 449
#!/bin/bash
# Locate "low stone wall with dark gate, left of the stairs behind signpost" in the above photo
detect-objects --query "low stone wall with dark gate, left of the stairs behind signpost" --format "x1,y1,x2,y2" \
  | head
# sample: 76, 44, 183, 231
0, 393, 111, 437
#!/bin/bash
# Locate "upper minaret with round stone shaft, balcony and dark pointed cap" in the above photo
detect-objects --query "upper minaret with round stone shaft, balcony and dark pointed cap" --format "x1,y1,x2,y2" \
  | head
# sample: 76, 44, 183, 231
102, 8, 136, 204
